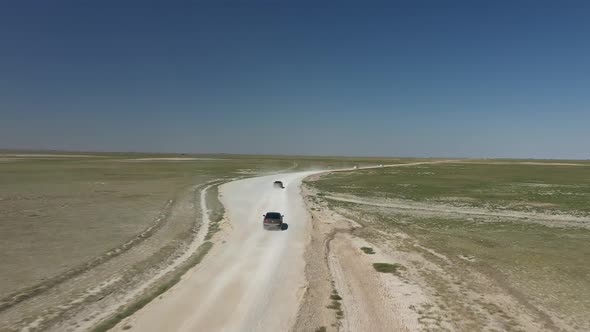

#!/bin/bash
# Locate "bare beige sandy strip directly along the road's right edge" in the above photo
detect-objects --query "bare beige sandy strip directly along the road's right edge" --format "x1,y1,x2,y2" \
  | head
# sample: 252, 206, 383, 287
293, 188, 427, 331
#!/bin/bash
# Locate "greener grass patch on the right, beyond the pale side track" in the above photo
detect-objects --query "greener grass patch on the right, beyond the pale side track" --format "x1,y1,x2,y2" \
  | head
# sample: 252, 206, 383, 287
314, 161, 590, 213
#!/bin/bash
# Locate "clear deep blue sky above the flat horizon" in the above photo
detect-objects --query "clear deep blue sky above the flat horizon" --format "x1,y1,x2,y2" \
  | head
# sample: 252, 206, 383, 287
0, 0, 590, 159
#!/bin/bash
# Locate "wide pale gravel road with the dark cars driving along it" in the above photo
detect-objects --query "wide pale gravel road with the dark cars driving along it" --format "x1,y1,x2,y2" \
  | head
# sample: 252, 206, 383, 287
115, 171, 318, 332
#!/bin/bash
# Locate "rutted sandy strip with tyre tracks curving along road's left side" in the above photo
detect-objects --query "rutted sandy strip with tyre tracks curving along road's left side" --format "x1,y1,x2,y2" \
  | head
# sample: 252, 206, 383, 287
0, 184, 224, 331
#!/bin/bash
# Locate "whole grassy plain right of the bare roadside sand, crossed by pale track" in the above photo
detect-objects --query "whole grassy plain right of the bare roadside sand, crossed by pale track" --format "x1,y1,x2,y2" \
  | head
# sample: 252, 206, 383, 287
308, 160, 590, 331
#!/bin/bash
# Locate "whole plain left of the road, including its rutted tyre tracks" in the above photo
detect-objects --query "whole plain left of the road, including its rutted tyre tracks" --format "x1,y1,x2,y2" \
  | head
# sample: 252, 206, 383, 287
0, 151, 408, 330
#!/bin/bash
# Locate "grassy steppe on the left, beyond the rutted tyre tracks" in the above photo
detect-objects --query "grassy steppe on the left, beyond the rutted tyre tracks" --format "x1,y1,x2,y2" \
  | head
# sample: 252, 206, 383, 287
0, 151, 418, 298
